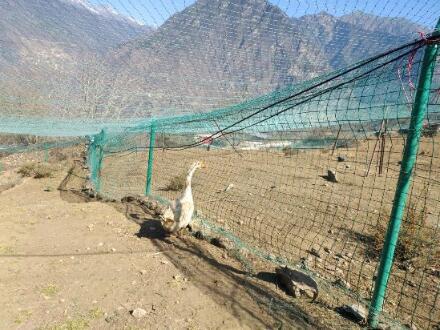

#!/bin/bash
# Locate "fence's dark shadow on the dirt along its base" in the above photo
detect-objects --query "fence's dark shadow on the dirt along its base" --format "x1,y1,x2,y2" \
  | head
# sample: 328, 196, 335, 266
58, 166, 328, 329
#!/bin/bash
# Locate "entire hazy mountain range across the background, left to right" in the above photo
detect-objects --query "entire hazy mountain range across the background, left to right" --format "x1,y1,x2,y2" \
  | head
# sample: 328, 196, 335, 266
0, 0, 423, 117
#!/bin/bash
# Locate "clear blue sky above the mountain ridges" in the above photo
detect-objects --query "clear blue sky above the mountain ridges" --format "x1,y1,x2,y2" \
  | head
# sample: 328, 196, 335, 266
89, 0, 440, 28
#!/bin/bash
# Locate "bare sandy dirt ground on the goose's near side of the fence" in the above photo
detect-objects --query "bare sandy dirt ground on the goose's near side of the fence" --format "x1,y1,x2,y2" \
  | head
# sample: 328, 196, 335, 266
0, 158, 356, 329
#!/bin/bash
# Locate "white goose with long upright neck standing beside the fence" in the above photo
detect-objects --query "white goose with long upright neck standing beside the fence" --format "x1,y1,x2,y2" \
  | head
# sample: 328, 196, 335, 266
161, 161, 204, 234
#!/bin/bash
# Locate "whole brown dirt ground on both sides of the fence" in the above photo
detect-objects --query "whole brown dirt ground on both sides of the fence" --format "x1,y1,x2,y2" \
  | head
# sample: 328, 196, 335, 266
0, 131, 440, 329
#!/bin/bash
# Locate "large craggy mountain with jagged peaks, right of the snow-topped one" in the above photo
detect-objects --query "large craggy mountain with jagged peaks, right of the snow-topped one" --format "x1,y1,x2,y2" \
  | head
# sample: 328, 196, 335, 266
114, 0, 418, 110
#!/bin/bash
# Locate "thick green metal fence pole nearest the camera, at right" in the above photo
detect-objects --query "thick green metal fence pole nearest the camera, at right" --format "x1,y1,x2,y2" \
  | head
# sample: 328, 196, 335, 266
368, 19, 440, 328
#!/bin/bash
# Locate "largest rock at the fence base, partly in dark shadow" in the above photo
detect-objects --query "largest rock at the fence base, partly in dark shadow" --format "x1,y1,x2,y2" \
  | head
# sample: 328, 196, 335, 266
275, 266, 318, 301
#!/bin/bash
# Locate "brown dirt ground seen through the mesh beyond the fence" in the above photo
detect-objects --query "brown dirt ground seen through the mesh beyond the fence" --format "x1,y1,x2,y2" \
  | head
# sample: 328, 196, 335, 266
101, 132, 440, 328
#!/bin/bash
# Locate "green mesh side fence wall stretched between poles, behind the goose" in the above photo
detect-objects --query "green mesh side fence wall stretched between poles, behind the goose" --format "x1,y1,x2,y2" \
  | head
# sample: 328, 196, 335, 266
84, 37, 440, 329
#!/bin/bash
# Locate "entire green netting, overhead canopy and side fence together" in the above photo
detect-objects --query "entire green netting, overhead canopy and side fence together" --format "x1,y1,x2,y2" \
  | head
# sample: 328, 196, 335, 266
0, 0, 440, 329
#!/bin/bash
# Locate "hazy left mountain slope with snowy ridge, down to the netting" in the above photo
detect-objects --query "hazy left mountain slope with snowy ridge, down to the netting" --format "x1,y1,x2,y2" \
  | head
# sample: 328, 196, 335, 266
0, 0, 153, 116
